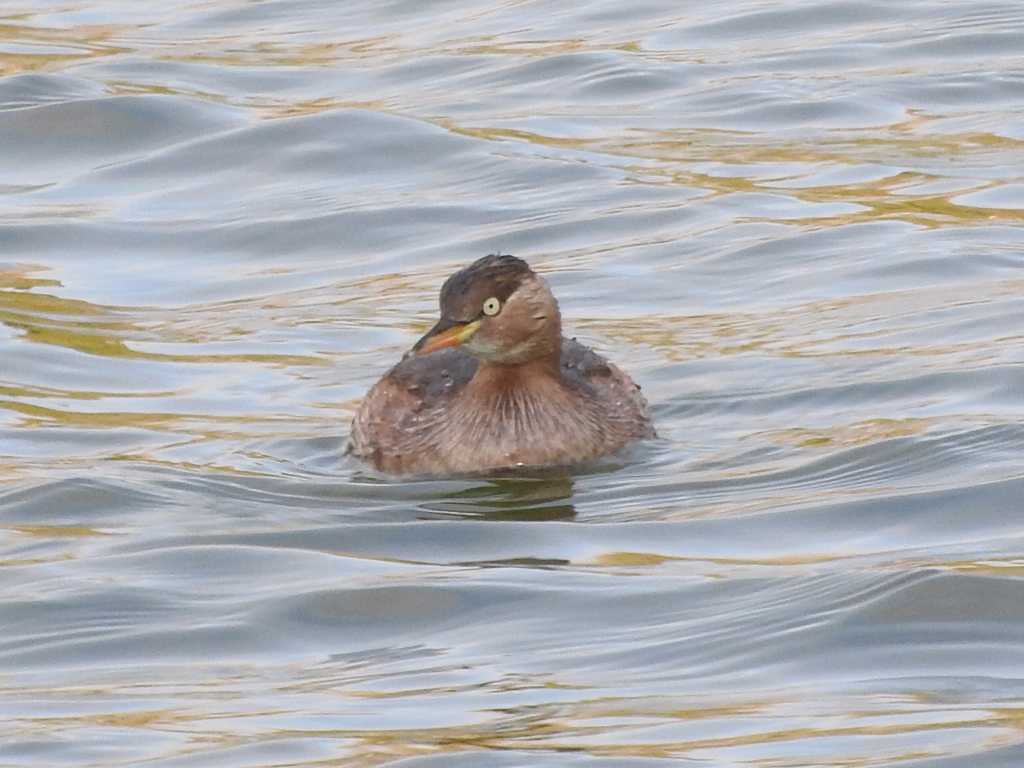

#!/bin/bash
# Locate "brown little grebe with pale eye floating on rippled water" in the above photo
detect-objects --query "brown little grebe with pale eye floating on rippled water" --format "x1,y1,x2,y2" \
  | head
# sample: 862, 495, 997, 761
349, 255, 654, 474
